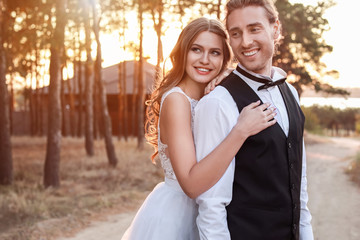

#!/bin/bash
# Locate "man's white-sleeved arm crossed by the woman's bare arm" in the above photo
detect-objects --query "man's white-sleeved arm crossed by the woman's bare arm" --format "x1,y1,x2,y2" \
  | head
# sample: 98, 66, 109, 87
194, 89, 238, 240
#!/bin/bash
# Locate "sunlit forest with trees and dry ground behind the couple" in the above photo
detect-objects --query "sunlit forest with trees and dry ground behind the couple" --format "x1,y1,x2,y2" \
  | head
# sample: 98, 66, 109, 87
0, 0, 360, 239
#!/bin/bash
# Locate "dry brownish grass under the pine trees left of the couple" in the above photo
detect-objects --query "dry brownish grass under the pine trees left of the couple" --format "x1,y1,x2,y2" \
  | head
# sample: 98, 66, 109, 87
0, 137, 163, 240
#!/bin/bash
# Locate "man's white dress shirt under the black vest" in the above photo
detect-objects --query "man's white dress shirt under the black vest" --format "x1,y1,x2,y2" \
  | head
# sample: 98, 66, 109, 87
194, 65, 314, 240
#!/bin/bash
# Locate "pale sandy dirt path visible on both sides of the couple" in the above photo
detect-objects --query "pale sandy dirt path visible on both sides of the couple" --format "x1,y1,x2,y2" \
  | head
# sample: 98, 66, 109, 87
58, 137, 360, 240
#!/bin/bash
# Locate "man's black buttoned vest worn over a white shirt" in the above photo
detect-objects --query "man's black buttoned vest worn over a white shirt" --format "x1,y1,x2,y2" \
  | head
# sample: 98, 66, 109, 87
221, 73, 305, 240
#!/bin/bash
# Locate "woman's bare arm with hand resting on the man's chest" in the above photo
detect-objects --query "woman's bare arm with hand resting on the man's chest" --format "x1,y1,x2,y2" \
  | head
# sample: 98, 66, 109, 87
160, 93, 275, 198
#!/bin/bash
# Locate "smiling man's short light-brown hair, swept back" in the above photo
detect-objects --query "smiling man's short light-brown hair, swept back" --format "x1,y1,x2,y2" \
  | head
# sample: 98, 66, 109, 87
226, 0, 279, 29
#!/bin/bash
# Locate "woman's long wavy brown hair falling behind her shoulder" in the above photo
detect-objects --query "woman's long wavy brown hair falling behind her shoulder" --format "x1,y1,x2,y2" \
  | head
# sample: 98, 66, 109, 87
145, 17, 231, 163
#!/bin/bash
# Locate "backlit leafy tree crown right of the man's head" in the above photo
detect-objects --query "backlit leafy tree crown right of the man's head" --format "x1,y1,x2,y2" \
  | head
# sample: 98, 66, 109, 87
274, 0, 349, 95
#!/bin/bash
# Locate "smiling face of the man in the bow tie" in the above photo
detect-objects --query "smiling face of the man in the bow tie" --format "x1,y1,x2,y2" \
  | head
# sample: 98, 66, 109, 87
227, 6, 279, 76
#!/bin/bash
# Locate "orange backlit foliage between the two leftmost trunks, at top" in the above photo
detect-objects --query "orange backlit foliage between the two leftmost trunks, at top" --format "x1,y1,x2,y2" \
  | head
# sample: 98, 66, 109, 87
5, 0, 52, 82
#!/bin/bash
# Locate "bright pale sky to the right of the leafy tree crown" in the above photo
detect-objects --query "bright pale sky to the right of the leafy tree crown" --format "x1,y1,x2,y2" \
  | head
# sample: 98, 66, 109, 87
290, 0, 360, 87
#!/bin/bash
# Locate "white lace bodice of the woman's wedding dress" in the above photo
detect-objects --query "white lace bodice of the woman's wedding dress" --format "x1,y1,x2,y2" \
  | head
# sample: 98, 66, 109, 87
158, 87, 198, 180
